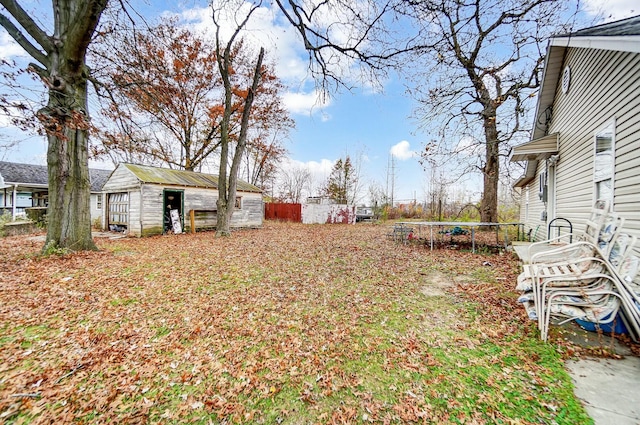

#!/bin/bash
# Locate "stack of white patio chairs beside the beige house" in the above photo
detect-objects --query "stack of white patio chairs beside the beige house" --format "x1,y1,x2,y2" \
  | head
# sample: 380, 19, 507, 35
517, 201, 640, 340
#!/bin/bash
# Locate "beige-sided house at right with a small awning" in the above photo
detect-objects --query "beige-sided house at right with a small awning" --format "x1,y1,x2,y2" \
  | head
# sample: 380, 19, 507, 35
511, 16, 640, 250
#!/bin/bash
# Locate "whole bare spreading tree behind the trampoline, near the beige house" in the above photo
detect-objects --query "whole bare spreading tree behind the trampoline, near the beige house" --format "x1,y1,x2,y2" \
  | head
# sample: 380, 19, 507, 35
404, 0, 569, 222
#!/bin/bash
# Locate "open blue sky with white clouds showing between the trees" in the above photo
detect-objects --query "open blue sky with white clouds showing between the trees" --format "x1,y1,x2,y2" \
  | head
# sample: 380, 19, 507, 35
0, 0, 640, 201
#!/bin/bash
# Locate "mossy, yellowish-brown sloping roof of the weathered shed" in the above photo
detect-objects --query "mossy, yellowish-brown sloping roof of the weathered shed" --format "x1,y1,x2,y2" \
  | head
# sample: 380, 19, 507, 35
121, 163, 262, 193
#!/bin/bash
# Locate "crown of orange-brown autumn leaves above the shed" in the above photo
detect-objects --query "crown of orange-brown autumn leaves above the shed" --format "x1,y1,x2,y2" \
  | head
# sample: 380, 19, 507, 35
95, 21, 293, 170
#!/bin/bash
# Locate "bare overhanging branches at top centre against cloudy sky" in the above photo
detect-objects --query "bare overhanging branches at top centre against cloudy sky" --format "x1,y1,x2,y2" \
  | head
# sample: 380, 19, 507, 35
275, 0, 412, 94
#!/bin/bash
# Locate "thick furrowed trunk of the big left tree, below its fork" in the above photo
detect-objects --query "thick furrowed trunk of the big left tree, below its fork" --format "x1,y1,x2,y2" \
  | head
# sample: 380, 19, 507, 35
40, 59, 97, 248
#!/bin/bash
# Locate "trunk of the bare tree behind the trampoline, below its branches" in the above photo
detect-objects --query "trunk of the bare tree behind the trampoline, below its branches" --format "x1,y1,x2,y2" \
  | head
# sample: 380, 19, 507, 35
480, 114, 500, 223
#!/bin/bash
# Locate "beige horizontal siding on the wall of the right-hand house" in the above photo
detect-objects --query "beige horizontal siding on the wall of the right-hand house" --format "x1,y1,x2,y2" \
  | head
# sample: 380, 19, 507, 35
529, 48, 640, 243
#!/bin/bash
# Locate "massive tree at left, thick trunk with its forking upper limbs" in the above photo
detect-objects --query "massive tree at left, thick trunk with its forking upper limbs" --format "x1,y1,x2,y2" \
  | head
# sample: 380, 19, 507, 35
0, 0, 107, 250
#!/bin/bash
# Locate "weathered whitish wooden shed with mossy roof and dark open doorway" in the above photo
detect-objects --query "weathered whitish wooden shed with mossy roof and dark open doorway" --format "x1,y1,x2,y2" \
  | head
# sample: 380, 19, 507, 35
102, 163, 264, 236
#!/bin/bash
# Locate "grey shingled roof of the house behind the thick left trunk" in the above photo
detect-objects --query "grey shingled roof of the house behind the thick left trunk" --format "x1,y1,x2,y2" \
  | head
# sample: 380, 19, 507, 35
0, 161, 111, 192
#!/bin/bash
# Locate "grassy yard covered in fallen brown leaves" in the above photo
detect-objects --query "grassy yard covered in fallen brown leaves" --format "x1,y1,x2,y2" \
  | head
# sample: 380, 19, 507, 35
0, 222, 591, 424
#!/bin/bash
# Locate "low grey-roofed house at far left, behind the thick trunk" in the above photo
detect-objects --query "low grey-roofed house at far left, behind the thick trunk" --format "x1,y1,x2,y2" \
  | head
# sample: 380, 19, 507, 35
0, 161, 111, 222
